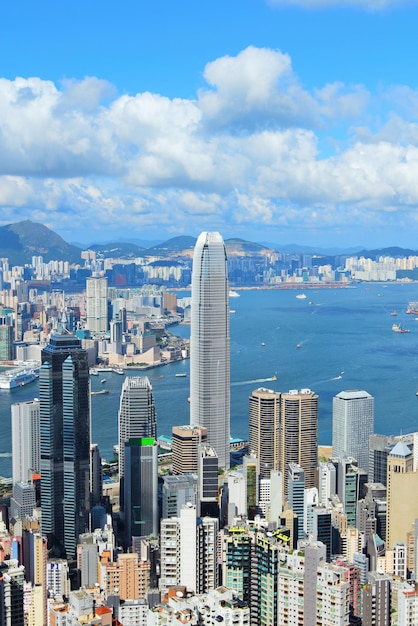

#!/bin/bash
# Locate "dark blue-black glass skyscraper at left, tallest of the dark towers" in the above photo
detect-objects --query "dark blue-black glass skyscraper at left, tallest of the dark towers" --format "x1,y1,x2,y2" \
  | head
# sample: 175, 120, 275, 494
39, 335, 90, 559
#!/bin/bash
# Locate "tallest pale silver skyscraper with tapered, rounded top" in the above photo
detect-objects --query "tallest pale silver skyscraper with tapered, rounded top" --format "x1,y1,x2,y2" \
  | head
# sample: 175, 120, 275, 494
190, 232, 230, 468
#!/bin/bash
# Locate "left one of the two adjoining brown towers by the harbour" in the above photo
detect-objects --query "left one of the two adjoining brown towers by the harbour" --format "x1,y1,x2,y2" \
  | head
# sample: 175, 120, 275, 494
249, 388, 280, 478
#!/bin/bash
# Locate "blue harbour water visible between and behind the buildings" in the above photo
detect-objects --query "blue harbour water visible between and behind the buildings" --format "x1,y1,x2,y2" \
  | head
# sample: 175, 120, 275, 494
0, 284, 418, 476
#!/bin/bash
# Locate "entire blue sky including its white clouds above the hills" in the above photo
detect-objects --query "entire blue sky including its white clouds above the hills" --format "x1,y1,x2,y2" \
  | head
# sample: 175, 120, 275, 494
0, 0, 418, 249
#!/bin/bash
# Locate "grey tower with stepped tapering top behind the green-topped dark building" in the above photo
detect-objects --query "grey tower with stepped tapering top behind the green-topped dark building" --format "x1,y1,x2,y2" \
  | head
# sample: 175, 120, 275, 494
119, 376, 157, 479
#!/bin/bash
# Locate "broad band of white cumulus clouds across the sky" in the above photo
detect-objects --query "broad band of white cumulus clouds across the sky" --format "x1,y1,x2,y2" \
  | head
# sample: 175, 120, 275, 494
0, 47, 418, 238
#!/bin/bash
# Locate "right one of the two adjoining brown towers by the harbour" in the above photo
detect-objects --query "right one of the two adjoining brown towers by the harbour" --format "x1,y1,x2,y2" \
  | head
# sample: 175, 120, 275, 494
278, 389, 318, 498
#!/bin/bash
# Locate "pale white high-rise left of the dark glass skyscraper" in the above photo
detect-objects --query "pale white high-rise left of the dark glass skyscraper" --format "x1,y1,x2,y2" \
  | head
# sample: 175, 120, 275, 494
12, 400, 40, 483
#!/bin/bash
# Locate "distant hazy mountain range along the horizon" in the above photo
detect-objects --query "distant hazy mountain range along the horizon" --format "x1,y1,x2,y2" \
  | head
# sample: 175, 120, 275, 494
0, 220, 417, 265
